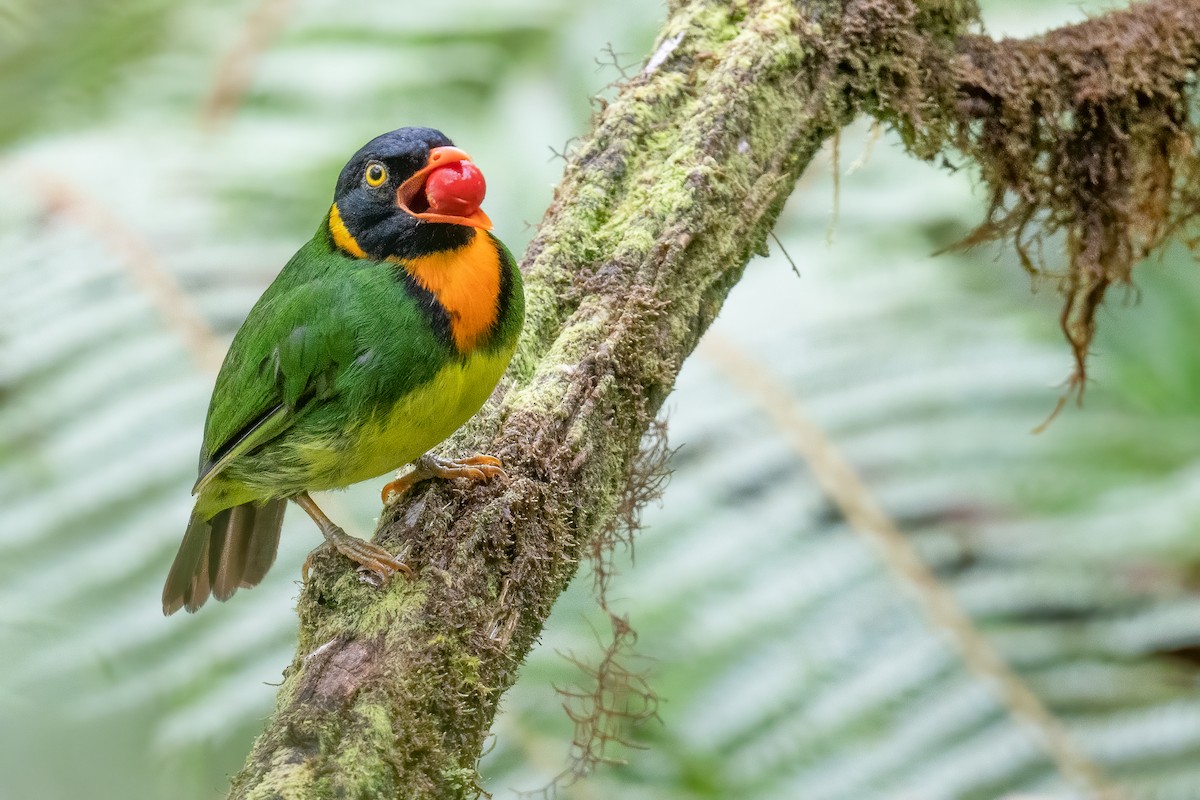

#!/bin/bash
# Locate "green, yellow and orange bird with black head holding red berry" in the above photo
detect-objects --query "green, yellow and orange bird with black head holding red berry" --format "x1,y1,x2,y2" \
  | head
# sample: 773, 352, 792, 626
162, 127, 524, 615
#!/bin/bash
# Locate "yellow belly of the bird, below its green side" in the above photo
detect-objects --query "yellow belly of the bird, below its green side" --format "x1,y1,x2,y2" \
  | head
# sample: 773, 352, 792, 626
313, 350, 512, 486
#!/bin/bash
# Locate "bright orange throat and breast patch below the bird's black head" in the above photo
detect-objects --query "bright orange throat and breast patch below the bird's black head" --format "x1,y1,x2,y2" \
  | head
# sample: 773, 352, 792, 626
388, 231, 500, 353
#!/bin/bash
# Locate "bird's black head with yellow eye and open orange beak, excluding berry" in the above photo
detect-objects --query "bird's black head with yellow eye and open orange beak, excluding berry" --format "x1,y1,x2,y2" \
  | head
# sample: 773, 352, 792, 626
329, 128, 492, 260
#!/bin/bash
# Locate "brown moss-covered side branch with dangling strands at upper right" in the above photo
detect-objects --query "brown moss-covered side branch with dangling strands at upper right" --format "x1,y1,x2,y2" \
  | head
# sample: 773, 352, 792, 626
869, 0, 1200, 392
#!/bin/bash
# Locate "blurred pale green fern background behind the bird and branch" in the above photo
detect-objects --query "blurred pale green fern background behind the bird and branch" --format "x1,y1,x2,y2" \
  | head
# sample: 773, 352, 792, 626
0, 0, 1200, 800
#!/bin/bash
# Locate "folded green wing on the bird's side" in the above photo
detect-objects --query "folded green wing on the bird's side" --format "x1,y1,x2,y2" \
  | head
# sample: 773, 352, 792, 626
192, 281, 359, 494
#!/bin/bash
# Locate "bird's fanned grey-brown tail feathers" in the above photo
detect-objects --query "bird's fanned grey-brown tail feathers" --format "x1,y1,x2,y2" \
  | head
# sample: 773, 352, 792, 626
162, 500, 287, 616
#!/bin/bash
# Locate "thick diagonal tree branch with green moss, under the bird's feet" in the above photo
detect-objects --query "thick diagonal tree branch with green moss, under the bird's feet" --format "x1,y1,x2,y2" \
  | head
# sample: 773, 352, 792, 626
230, 0, 1195, 800
